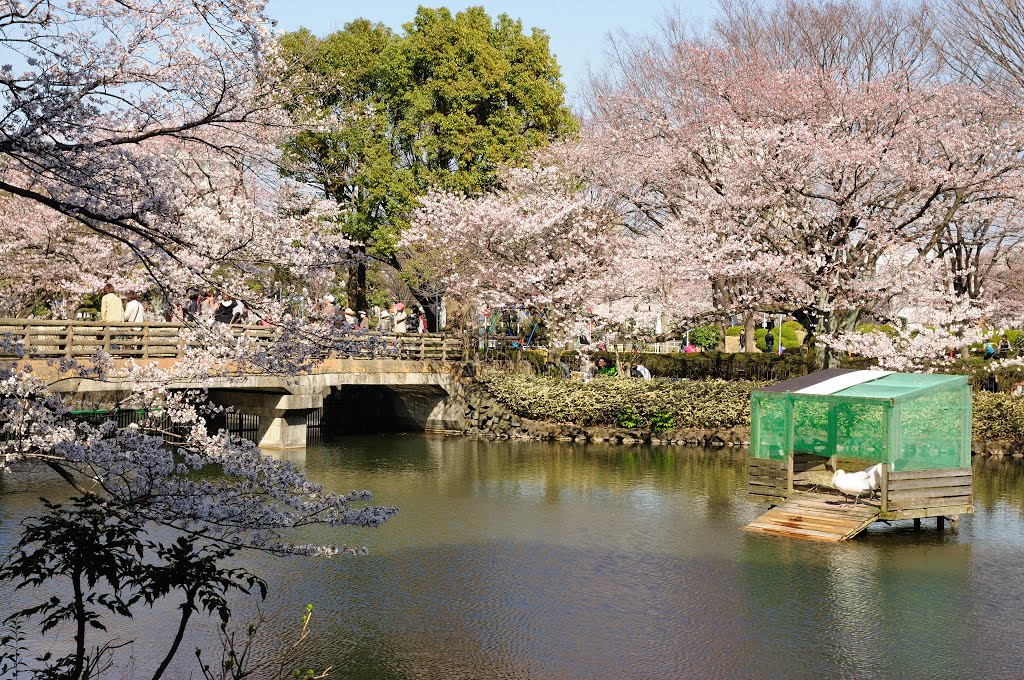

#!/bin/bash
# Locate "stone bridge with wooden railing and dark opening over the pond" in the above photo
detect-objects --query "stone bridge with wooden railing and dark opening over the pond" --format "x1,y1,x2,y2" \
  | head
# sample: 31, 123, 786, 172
0, 318, 479, 449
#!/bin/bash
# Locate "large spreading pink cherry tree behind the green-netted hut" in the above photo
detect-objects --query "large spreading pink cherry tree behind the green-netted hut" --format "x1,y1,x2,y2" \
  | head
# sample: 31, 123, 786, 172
579, 27, 1020, 364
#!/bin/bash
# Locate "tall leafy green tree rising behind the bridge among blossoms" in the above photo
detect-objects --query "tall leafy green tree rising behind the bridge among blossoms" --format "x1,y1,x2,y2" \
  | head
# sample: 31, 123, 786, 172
283, 7, 578, 307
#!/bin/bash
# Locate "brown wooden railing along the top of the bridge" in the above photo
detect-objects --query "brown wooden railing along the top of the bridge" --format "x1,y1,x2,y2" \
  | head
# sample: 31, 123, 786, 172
0, 318, 464, 360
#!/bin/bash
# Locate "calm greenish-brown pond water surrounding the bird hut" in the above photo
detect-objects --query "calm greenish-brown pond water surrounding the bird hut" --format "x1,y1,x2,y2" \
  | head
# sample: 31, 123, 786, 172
0, 435, 1024, 680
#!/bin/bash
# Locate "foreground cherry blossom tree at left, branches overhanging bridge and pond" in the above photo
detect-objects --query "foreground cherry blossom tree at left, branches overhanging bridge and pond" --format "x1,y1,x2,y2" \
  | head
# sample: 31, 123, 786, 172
0, 0, 394, 677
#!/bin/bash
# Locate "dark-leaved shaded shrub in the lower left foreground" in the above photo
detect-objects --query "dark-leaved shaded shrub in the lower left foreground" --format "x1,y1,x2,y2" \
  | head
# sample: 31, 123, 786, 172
0, 496, 266, 678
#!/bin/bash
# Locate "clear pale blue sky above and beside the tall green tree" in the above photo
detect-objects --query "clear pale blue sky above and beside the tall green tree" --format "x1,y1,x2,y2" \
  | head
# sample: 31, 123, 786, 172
267, 0, 713, 100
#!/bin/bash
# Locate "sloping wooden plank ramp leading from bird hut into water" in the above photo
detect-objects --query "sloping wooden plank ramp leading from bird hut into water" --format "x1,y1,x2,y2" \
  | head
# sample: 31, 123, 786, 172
746, 494, 881, 541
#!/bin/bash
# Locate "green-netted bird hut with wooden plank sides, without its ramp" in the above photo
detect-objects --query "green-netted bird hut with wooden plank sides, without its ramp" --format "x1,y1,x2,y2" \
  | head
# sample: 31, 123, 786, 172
748, 369, 974, 519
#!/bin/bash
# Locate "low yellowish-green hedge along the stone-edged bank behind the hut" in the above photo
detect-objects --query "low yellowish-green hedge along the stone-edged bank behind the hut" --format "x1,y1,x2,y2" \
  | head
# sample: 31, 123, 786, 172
480, 371, 1024, 441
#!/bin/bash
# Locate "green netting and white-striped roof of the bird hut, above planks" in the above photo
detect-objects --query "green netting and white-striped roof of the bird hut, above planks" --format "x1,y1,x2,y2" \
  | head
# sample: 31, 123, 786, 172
751, 369, 971, 472
